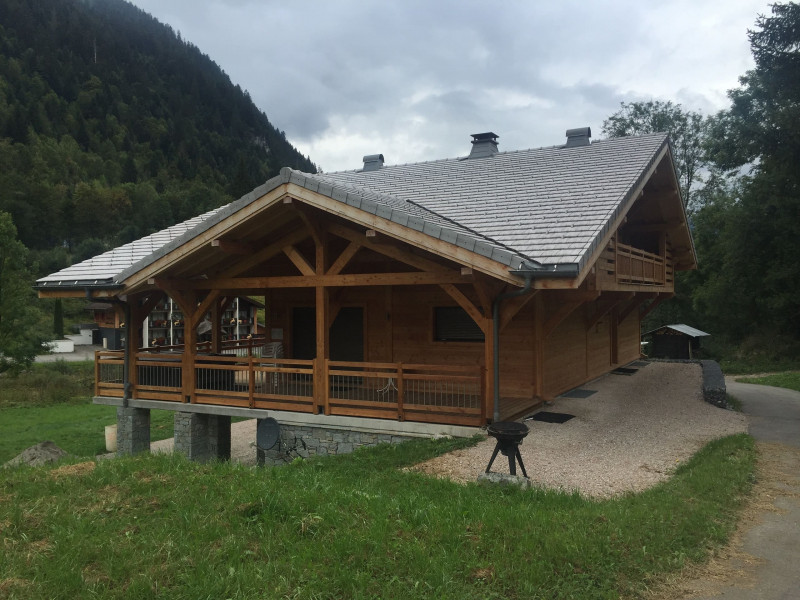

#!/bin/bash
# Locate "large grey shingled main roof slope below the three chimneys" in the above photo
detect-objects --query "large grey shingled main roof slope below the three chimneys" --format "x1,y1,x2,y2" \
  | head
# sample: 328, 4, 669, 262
312, 134, 667, 266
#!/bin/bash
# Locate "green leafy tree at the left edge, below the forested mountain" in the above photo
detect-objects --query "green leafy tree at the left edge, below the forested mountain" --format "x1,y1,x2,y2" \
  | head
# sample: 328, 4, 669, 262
0, 212, 47, 373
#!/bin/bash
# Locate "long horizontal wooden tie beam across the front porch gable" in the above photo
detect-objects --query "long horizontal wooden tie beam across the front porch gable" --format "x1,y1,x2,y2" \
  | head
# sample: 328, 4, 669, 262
155, 271, 470, 292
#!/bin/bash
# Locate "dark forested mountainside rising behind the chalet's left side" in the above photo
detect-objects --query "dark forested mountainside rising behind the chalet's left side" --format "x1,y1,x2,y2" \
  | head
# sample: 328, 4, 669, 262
0, 0, 315, 272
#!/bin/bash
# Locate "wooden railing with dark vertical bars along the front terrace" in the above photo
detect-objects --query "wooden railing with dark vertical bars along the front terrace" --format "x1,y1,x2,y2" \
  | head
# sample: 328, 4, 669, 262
95, 348, 485, 426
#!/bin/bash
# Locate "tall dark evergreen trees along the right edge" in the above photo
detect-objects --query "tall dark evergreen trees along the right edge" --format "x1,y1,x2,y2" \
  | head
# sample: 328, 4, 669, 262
700, 3, 800, 340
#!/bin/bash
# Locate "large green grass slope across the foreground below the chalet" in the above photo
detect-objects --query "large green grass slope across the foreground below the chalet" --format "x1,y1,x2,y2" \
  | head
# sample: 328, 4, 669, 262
0, 435, 755, 600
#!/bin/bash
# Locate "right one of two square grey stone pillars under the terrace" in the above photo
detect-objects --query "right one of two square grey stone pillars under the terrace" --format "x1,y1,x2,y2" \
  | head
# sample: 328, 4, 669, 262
175, 412, 231, 462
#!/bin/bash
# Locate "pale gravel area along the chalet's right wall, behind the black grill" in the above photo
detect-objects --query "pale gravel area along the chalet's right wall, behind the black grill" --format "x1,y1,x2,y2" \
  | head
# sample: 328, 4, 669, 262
415, 362, 747, 498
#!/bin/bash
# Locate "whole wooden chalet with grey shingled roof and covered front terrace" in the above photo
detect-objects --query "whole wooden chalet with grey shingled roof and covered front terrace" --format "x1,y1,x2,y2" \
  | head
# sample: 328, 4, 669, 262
37, 128, 696, 440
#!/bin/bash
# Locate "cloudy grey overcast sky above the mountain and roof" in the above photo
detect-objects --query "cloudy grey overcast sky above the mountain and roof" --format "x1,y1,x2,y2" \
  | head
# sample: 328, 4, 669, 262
128, 0, 769, 171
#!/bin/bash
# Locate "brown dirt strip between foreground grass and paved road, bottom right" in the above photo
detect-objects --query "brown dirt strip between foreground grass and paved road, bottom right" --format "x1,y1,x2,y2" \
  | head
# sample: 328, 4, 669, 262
646, 442, 800, 600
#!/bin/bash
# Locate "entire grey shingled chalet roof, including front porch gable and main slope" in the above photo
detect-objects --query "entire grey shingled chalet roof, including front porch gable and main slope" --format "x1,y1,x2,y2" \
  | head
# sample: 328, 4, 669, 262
36, 134, 667, 288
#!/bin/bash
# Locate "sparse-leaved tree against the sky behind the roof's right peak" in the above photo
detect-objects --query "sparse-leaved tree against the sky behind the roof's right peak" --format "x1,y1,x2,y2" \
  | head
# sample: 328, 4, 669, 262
602, 100, 707, 206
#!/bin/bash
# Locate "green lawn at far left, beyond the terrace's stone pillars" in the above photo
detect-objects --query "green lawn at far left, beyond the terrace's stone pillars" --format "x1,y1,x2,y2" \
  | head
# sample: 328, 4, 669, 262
0, 362, 173, 464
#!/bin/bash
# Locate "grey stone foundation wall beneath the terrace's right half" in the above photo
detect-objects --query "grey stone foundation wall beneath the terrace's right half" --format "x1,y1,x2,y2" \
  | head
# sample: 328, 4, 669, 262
258, 423, 416, 465
